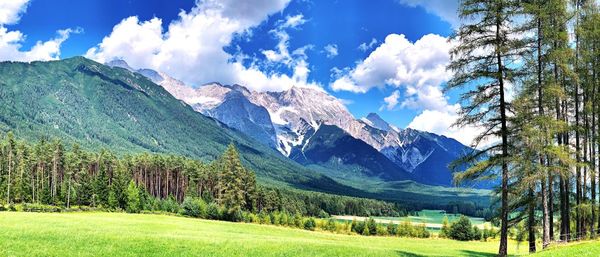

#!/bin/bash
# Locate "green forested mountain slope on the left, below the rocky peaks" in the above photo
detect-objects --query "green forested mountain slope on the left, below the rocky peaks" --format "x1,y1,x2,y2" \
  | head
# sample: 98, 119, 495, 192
0, 57, 358, 194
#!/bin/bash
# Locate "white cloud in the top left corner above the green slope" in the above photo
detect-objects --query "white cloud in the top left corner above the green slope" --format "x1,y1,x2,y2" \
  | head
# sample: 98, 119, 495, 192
0, 0, 81, 62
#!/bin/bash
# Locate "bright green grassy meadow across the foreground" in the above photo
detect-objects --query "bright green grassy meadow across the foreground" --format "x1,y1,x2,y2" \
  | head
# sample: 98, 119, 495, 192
0, 212, 525, 256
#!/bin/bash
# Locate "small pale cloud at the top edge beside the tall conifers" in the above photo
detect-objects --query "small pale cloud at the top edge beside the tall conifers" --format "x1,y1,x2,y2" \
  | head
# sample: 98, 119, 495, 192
400, 0, 460, 28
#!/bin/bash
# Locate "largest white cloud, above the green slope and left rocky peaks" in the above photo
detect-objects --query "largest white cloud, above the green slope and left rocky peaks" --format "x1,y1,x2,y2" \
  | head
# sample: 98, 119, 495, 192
86, 0, 319, 91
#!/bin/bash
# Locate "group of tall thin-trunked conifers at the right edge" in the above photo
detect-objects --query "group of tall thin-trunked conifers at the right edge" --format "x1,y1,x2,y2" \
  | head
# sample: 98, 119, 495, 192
447, 0, 600, 256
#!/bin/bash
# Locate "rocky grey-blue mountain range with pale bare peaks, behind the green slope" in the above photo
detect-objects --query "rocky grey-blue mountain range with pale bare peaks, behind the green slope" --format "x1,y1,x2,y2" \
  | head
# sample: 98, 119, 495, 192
107, 60, 473, 186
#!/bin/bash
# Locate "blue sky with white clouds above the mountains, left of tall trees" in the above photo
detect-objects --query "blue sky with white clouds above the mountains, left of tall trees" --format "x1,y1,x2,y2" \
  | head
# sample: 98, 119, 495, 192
0, 0, 476, 144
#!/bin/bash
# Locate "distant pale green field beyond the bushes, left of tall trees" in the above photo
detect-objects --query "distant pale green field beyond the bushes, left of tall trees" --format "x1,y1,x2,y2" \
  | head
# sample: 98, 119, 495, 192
334, 210, 492, 230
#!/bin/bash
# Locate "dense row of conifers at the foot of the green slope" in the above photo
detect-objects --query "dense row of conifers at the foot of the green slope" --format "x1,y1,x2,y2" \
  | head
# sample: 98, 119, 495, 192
0, 132, 405, 219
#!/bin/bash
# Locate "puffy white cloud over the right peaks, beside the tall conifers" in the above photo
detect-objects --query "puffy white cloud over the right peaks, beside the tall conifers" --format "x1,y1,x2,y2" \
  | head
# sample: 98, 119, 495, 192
330, 34, 480, 145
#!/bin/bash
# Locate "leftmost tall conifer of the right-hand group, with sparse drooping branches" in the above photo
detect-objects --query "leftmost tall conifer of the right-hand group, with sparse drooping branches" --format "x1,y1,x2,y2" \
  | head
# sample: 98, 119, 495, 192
447, 0, 523, 256
